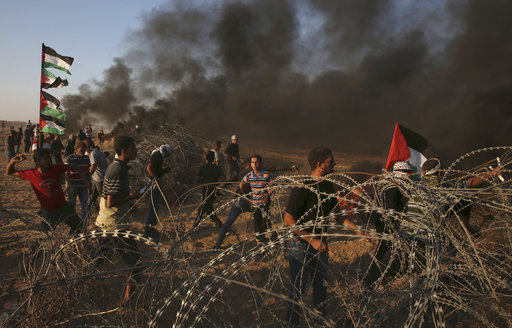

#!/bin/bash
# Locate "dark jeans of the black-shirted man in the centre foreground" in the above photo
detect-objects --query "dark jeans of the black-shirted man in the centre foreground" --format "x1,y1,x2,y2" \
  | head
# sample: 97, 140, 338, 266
287, 238, 329, 325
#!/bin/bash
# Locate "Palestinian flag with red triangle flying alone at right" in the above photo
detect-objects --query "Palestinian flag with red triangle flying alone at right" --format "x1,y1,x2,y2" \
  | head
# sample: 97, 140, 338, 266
386, 123, 437, 174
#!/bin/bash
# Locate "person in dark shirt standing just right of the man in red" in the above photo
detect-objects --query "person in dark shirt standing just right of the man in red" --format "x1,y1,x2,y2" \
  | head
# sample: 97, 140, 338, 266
66, 140, 91, 227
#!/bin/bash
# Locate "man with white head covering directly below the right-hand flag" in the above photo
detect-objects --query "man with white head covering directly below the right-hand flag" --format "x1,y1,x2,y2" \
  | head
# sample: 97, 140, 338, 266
364, 162, 414, 287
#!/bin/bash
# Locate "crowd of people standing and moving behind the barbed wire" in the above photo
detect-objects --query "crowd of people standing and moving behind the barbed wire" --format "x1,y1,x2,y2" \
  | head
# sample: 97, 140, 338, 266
6, 121, 502, 325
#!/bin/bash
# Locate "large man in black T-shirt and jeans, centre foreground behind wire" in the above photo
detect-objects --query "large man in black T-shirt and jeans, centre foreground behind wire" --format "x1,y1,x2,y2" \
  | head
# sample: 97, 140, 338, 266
284, 147, 343, 325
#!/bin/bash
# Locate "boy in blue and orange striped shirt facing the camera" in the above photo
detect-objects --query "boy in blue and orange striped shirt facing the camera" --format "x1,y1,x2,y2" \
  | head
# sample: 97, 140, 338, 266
240, 155, 273, 242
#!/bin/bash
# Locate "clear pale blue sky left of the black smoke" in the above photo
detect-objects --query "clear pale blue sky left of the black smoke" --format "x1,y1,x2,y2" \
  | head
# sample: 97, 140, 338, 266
0, 0, 163, 121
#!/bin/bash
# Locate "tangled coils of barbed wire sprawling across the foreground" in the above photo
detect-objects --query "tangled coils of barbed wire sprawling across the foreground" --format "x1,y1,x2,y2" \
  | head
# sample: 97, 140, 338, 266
0, 135, 512, 327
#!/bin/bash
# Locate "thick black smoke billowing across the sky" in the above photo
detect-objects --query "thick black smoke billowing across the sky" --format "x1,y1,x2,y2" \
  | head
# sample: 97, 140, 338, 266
63, 0, 512, 164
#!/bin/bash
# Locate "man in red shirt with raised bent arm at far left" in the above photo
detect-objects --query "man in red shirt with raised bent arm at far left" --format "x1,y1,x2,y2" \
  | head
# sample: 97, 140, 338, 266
6, 149, 82, 233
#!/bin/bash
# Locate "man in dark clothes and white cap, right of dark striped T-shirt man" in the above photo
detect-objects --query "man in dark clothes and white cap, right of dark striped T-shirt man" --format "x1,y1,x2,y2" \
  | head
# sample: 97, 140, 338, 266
144, 145, 173, 238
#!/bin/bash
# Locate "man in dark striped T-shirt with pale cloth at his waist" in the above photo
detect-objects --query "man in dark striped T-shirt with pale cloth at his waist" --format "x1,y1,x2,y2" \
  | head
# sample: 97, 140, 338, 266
96, 136, 141, 301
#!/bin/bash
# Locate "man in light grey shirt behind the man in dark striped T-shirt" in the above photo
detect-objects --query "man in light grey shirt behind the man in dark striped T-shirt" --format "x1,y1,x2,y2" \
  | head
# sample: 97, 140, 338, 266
84, 139, 107, 210
